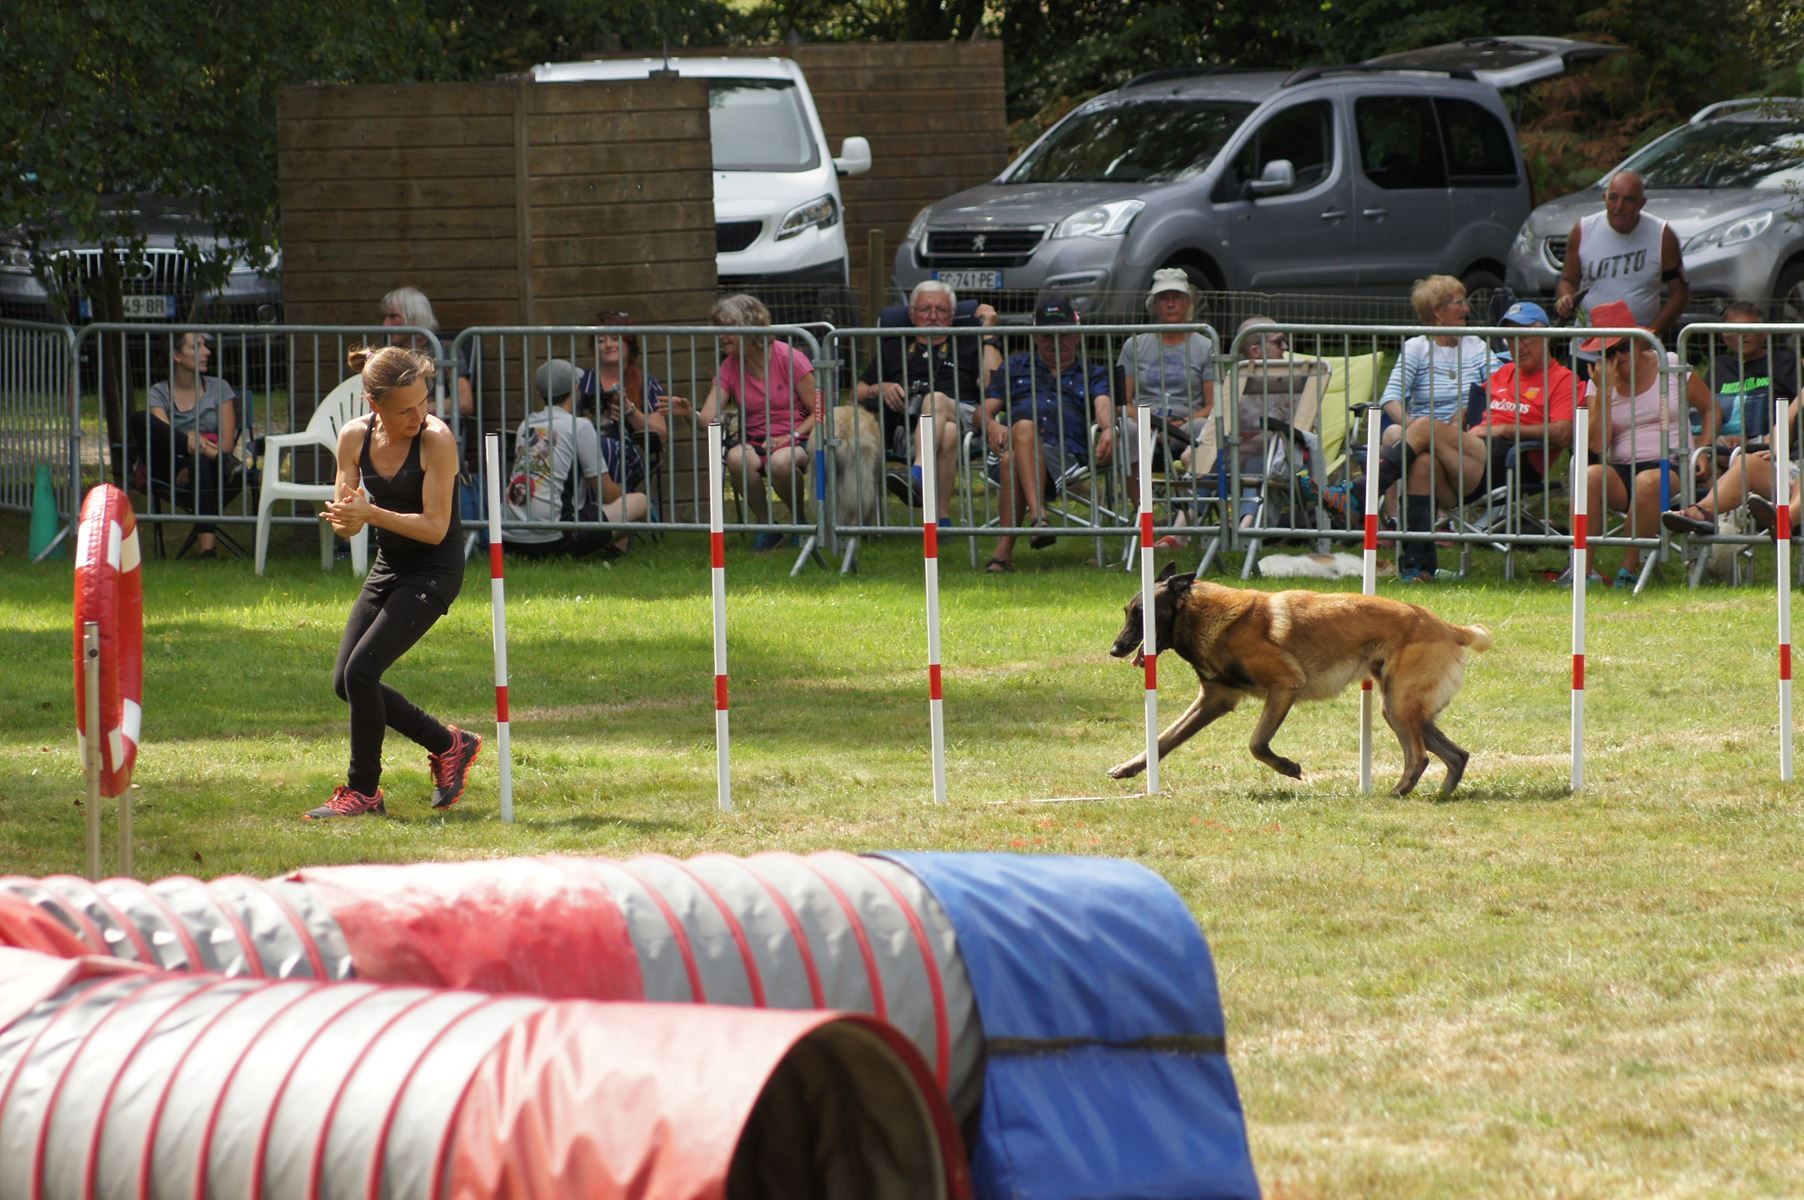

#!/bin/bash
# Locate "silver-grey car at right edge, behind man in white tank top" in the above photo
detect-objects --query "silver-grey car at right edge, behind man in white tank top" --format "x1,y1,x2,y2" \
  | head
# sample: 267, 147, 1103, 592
1508, 97, 1804, 321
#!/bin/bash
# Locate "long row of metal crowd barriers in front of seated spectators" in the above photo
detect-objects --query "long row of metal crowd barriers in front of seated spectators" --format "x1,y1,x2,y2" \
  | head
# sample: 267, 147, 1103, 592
10, 314, 1804, 583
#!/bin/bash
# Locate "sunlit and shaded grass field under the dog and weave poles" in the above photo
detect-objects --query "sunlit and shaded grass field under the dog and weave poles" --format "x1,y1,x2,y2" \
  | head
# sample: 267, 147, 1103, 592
0, 518, 1804, 1200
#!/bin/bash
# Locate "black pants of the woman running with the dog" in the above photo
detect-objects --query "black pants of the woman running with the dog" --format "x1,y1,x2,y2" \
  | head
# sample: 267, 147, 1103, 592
332, 579, 451, 796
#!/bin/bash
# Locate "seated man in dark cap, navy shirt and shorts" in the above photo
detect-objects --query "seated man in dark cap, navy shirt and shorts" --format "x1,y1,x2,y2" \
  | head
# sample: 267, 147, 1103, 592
978, 296, 1115, 574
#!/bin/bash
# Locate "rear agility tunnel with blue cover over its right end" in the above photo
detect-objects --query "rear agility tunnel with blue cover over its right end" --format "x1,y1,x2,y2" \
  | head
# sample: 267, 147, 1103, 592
0, 854, 1257, 1200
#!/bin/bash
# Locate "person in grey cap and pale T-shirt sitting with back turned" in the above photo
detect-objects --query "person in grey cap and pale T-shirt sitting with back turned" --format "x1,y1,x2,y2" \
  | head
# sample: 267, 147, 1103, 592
503, 359, 651, 558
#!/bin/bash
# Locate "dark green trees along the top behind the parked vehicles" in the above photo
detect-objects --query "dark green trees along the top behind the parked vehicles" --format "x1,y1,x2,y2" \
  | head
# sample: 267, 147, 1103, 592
0, 0, 1804, 297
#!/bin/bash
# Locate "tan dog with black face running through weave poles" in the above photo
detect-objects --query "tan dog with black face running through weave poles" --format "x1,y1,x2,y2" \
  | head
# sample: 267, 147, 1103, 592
1109, 565, 1492, 796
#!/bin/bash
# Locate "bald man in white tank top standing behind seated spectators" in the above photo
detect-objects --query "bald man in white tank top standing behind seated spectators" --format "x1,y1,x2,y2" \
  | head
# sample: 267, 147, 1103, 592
1553, 171, 1690, 337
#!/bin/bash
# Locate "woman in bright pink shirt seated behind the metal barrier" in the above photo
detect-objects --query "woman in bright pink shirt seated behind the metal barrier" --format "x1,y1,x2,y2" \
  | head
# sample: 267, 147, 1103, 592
669, 294, 817, 550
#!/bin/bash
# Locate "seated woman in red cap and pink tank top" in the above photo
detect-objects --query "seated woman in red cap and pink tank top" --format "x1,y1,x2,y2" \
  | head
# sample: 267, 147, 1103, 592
1579, 301, 1716, 588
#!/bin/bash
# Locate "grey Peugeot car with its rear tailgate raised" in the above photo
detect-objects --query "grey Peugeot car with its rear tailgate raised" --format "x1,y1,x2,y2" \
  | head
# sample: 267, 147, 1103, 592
895, 38, 1611, 319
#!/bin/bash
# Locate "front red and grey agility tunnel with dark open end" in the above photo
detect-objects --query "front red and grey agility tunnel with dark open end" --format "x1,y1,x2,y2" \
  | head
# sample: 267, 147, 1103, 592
0, 949, 971, 1200
